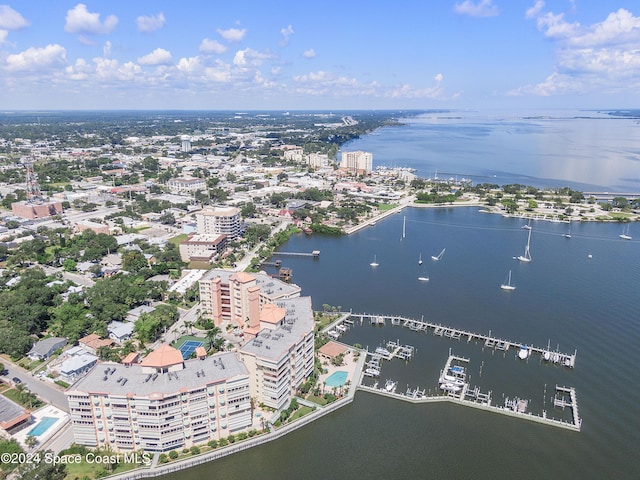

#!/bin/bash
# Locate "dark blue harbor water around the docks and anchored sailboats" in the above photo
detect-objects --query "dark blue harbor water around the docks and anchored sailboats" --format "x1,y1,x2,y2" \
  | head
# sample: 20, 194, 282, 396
166, 208, 640, 480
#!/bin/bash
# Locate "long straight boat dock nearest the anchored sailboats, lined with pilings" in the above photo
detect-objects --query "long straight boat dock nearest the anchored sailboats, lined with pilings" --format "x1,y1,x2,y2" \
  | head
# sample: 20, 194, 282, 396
349, 313, 577, 368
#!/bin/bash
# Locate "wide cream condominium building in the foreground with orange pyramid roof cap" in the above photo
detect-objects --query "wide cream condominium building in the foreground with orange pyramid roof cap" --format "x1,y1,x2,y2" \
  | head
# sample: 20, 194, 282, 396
66, 344, 252, 452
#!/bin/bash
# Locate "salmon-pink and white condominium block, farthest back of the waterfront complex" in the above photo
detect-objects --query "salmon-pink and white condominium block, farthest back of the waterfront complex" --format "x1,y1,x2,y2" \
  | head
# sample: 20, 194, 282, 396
199, 269, 300, 327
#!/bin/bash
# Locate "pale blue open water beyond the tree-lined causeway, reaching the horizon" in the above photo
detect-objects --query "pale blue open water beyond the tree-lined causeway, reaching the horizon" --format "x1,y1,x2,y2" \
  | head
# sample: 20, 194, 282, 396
343, 110, 640, 192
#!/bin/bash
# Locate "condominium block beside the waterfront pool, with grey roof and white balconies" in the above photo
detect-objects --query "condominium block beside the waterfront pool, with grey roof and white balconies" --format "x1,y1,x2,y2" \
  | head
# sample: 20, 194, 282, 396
239, 297, 314, 409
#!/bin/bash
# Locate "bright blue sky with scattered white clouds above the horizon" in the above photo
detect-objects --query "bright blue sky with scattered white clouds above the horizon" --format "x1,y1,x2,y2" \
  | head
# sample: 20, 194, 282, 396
0, 0, 640, 110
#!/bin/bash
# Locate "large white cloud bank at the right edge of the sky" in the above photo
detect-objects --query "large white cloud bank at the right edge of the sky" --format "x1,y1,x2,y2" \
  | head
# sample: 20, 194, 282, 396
520, 3, 640, 96
